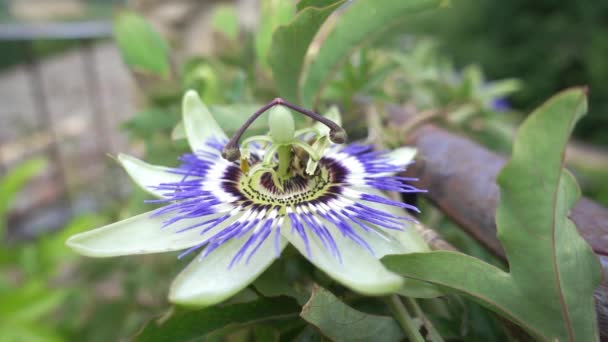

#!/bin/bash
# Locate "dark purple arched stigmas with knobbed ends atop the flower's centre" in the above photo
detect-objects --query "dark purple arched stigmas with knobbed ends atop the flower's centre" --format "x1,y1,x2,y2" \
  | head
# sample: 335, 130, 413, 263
222, 98, 347, 161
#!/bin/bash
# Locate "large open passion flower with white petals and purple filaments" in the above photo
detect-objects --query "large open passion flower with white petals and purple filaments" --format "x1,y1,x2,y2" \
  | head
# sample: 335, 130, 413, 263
67, 91, 428, 306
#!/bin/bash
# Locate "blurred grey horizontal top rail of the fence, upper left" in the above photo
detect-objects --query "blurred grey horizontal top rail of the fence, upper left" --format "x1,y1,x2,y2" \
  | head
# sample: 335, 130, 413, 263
0, 21, 112, 41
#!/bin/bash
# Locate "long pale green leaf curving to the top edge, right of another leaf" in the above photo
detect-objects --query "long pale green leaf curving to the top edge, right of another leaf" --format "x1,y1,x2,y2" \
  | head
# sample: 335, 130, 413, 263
300, 0, 439, 107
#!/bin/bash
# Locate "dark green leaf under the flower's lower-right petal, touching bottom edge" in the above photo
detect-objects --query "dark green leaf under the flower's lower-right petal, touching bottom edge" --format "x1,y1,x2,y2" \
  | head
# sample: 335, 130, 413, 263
300, 287, 404, 342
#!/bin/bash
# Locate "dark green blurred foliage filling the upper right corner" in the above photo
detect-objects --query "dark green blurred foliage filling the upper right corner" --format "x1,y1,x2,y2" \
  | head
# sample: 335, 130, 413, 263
405, 0, 608, 145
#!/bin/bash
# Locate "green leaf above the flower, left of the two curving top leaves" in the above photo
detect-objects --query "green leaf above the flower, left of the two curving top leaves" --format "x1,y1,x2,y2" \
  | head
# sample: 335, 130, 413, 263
268, 0, 345, 103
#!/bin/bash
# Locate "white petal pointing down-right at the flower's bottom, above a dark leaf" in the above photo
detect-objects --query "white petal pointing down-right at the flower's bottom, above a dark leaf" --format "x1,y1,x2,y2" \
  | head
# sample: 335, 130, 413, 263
281, 219, 403, 295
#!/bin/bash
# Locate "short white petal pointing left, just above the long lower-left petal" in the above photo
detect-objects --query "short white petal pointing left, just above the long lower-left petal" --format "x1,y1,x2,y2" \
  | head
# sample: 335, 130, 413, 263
118, 154, 184, 198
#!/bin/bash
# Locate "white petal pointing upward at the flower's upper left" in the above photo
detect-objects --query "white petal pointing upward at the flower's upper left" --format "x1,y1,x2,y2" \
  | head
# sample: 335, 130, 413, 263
182, 90, 228, 152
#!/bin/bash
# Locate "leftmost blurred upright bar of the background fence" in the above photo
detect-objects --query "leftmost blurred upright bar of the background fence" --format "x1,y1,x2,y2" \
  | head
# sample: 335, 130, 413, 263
23, 41, 71, 214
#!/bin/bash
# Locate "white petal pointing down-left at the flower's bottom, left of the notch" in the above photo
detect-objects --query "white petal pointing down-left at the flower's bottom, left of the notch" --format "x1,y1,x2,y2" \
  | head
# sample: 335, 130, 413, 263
169, 232, 287, 306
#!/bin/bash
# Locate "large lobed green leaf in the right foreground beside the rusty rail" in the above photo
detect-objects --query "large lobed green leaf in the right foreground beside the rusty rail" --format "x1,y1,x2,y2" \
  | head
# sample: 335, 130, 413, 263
383, 89, 600, 341
